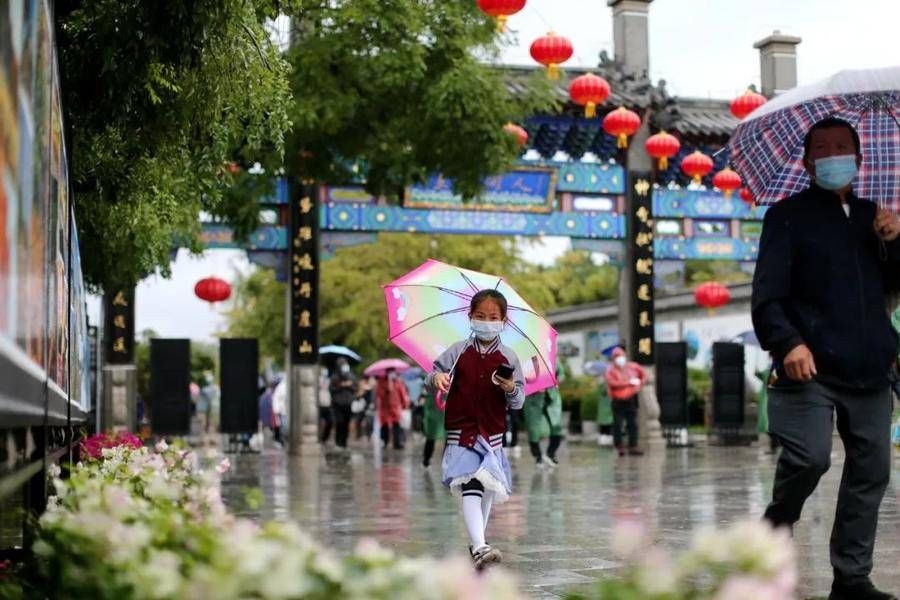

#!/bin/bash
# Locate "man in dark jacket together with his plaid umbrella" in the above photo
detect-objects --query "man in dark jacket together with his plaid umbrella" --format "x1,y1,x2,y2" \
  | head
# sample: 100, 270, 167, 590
729, 68, 900, 600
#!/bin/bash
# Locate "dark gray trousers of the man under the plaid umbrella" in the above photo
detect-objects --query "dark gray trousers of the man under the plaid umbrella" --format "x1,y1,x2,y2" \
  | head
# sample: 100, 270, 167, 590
765, 382, 892, 583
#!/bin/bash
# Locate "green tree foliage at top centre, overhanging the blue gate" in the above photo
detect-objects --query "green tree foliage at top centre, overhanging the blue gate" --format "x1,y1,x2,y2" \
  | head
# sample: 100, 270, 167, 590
286, 0, 557, 198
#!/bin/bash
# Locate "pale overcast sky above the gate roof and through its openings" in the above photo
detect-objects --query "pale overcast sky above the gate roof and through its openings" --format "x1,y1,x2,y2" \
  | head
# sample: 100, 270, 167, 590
114, 0, 900, 340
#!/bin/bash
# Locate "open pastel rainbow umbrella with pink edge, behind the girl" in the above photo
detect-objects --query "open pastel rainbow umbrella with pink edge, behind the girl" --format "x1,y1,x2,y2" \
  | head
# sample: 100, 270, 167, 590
384, 260, 557, 394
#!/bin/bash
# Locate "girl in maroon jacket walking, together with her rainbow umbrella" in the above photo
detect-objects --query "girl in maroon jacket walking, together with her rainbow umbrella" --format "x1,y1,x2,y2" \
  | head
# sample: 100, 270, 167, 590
385, 260, 556, 569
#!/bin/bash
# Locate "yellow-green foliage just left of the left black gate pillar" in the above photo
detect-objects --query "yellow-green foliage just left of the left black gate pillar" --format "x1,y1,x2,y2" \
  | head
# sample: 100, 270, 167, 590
226, 269, 285, 366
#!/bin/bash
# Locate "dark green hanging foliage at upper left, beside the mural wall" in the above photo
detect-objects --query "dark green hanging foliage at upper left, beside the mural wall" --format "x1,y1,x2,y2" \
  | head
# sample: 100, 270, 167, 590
55, 0, 290, 289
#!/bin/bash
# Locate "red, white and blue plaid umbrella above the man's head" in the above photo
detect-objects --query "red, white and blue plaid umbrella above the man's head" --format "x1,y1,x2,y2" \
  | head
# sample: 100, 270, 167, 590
728, 67, 900, 212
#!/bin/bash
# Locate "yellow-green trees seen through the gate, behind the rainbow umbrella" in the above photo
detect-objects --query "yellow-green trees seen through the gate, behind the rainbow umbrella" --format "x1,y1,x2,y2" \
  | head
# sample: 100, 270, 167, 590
221, 233, 555, 365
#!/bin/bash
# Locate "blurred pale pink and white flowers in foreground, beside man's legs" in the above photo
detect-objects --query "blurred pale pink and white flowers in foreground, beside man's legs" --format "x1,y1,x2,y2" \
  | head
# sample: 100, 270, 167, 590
569, 519, 797, 600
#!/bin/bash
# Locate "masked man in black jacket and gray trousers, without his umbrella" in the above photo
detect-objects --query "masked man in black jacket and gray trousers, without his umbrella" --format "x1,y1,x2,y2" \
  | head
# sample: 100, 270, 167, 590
753, 118, 900, 600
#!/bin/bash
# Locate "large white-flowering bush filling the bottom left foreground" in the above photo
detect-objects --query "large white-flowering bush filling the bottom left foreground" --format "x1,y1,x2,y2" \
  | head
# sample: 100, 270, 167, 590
22, 442, 518, 600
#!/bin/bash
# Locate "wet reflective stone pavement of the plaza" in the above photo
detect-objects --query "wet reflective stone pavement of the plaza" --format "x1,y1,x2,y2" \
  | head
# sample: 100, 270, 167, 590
223, 440, 900, 598
